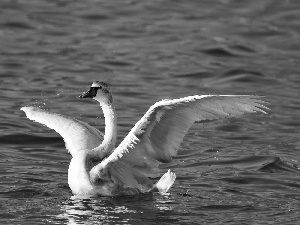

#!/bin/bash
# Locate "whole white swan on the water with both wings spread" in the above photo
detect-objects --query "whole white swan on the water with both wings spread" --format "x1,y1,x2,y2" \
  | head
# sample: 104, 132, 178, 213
21, 81, 268, 196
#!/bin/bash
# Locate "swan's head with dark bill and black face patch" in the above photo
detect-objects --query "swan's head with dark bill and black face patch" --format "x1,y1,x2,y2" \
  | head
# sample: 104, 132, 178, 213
79, 81, 113, 104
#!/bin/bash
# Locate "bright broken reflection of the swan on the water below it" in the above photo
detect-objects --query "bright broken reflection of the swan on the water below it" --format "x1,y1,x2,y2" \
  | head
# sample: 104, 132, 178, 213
58, 194, 174, 224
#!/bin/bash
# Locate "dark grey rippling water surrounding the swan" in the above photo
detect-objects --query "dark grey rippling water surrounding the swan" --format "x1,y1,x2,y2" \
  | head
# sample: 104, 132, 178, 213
0, 0, 300, 224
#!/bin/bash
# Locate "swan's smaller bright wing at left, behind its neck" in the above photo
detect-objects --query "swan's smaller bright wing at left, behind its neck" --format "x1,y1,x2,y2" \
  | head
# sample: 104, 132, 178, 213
21, 106, 103, 156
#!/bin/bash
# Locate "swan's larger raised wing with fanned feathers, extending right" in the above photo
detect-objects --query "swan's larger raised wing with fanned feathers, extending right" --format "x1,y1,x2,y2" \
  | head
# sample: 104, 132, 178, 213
100, 95, 268, 177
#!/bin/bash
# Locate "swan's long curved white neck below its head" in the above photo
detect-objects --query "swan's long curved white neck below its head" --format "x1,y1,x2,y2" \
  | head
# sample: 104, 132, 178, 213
99, 103, 117, 152
